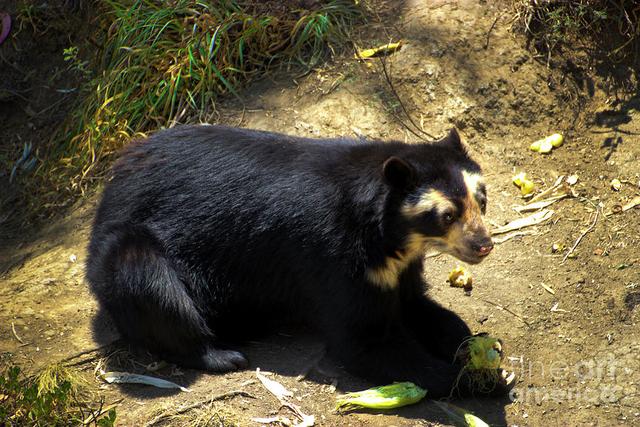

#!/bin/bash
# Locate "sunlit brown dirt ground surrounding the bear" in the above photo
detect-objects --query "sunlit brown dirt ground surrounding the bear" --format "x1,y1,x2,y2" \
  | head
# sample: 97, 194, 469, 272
0, 0, 640, 426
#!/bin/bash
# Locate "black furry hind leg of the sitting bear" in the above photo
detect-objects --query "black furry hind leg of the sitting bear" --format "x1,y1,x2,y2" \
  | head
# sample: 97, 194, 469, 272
87, 225, 248, 372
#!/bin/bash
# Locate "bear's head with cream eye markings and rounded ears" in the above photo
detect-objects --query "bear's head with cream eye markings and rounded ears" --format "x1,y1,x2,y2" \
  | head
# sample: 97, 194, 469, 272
382, 129, 493, 264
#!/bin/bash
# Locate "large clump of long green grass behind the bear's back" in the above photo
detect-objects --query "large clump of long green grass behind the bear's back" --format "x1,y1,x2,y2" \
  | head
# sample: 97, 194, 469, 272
18, 0, 361, 214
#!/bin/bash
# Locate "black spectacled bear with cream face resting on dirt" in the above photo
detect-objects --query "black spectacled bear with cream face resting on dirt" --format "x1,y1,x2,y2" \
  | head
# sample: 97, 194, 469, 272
87, 125, 506, 397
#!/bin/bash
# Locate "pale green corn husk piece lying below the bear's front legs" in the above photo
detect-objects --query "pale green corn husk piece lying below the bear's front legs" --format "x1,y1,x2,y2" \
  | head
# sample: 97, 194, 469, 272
336, 382, 427, 410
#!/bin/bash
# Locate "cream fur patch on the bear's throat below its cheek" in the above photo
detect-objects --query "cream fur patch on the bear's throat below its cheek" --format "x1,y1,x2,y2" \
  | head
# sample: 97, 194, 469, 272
367, 233, 428, 289
